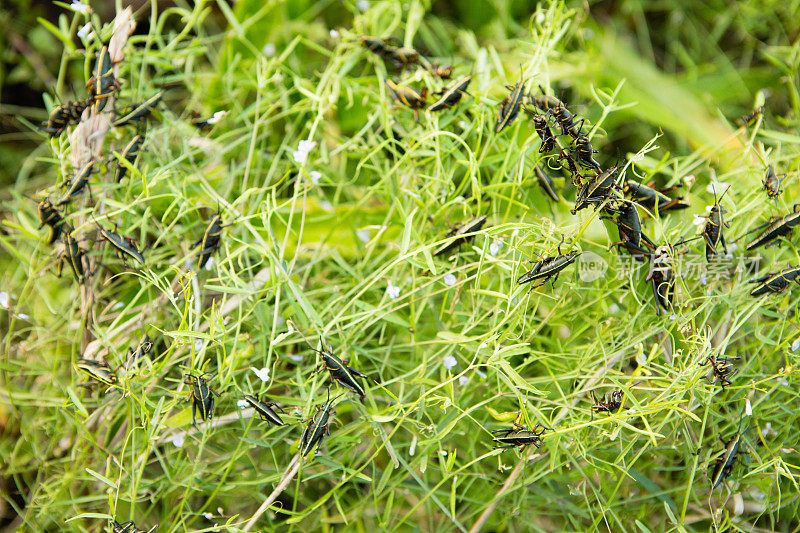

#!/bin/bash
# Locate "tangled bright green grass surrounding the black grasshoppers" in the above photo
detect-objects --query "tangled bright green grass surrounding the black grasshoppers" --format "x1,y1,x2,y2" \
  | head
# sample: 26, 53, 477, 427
0, 0, 800, 532
